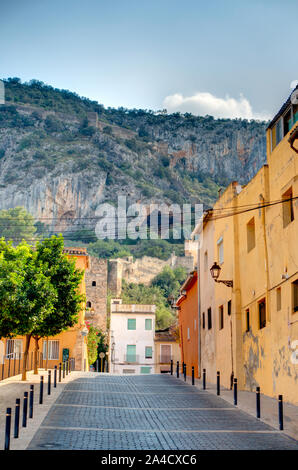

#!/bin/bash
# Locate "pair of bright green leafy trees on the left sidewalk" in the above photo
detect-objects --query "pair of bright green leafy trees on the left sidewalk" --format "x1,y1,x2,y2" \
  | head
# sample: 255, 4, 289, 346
0, 236, 84, 380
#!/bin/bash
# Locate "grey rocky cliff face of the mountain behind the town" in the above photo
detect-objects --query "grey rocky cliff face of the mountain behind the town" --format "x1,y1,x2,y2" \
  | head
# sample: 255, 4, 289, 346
0, 80, 266, 230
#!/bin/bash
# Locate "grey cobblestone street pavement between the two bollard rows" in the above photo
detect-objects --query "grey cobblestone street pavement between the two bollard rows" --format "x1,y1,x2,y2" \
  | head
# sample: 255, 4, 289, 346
28, 374, 298, 450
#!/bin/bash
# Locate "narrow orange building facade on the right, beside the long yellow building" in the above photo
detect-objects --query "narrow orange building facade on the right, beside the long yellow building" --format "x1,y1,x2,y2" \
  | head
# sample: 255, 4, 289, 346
176, 271, 199, 377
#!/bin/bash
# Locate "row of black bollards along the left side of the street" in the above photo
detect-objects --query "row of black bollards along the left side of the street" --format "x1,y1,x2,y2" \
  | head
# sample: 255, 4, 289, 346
4, 360, 71, 450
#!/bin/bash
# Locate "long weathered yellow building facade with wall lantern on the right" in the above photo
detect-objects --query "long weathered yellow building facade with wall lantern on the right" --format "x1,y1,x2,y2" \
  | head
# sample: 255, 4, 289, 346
193, 85, 298, 404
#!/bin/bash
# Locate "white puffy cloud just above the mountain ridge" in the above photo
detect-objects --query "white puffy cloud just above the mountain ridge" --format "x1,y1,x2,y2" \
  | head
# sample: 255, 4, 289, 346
163, 92, 270, 120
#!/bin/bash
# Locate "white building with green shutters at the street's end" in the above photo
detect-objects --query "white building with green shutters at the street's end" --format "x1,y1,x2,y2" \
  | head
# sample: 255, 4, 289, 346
110, 299, 156, 374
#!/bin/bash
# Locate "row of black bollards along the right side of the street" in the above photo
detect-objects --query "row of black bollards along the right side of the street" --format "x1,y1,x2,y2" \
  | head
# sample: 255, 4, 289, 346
171, 360, 284, 431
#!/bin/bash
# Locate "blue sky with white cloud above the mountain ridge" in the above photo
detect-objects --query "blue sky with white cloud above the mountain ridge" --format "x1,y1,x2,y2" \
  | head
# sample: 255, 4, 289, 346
0, 0, 298, 118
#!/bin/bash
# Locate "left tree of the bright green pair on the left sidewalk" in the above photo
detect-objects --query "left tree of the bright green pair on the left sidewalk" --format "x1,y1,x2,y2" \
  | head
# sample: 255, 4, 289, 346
0, 239, 56, 380
